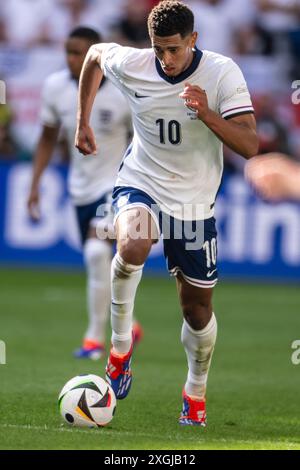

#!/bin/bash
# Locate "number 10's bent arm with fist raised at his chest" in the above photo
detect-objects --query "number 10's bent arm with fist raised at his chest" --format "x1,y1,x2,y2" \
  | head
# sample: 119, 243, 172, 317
180, 83, 258, 159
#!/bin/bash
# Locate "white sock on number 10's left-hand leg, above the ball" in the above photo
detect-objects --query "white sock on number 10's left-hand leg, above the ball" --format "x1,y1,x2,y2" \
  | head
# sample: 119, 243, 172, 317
111, 253, 144, 354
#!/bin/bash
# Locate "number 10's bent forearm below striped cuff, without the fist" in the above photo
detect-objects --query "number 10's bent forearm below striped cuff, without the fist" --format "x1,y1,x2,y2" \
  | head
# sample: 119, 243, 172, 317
202, 110, 258, 159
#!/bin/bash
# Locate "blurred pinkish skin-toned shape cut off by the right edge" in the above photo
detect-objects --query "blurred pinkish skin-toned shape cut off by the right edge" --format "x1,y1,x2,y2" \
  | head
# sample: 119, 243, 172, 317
245, 152, 300, 202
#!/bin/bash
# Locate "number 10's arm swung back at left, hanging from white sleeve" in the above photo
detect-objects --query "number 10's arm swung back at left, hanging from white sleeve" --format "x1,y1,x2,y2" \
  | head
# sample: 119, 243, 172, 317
75, 44, 105, 155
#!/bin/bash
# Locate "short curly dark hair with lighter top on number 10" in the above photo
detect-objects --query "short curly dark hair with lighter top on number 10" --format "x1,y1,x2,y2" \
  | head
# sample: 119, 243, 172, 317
148, 0, 194, 38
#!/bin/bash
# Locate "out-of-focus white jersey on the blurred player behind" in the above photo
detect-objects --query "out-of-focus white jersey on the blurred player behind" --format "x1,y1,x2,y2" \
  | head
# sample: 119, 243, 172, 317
41, 70, 131, 206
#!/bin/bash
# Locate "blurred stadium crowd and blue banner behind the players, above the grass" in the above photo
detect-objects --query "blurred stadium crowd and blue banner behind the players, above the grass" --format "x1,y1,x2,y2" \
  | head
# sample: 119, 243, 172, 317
0, 0, 300, 281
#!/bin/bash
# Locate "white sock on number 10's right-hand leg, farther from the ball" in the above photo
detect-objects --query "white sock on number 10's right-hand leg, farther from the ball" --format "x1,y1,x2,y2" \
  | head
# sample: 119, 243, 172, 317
181, 313, 217, 398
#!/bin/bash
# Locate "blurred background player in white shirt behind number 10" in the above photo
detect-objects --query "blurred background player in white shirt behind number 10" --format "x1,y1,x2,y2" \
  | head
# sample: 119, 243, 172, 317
28, 27, 141, 359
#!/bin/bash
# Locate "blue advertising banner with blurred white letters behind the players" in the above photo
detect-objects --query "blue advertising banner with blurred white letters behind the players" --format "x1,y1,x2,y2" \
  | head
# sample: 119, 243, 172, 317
0, 163, 300, 281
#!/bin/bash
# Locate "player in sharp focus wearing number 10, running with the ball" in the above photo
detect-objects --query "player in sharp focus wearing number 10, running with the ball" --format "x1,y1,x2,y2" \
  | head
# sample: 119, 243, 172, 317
75, 0, 258, 426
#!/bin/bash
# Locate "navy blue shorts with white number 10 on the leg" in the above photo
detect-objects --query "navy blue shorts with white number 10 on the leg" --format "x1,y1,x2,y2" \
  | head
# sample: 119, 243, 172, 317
112, 186, 218, 288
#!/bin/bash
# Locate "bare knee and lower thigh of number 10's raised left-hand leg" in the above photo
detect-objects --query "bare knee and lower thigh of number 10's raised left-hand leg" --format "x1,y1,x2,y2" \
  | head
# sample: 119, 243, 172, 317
116, 207, 158, 265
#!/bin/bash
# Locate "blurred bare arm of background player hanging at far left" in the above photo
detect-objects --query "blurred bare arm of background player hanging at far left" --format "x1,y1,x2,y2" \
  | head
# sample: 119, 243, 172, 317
27, 125, 59, 220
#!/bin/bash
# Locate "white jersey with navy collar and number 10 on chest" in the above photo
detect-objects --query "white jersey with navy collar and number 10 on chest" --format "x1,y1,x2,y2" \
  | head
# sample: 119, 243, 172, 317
100, 43, 253, 220
